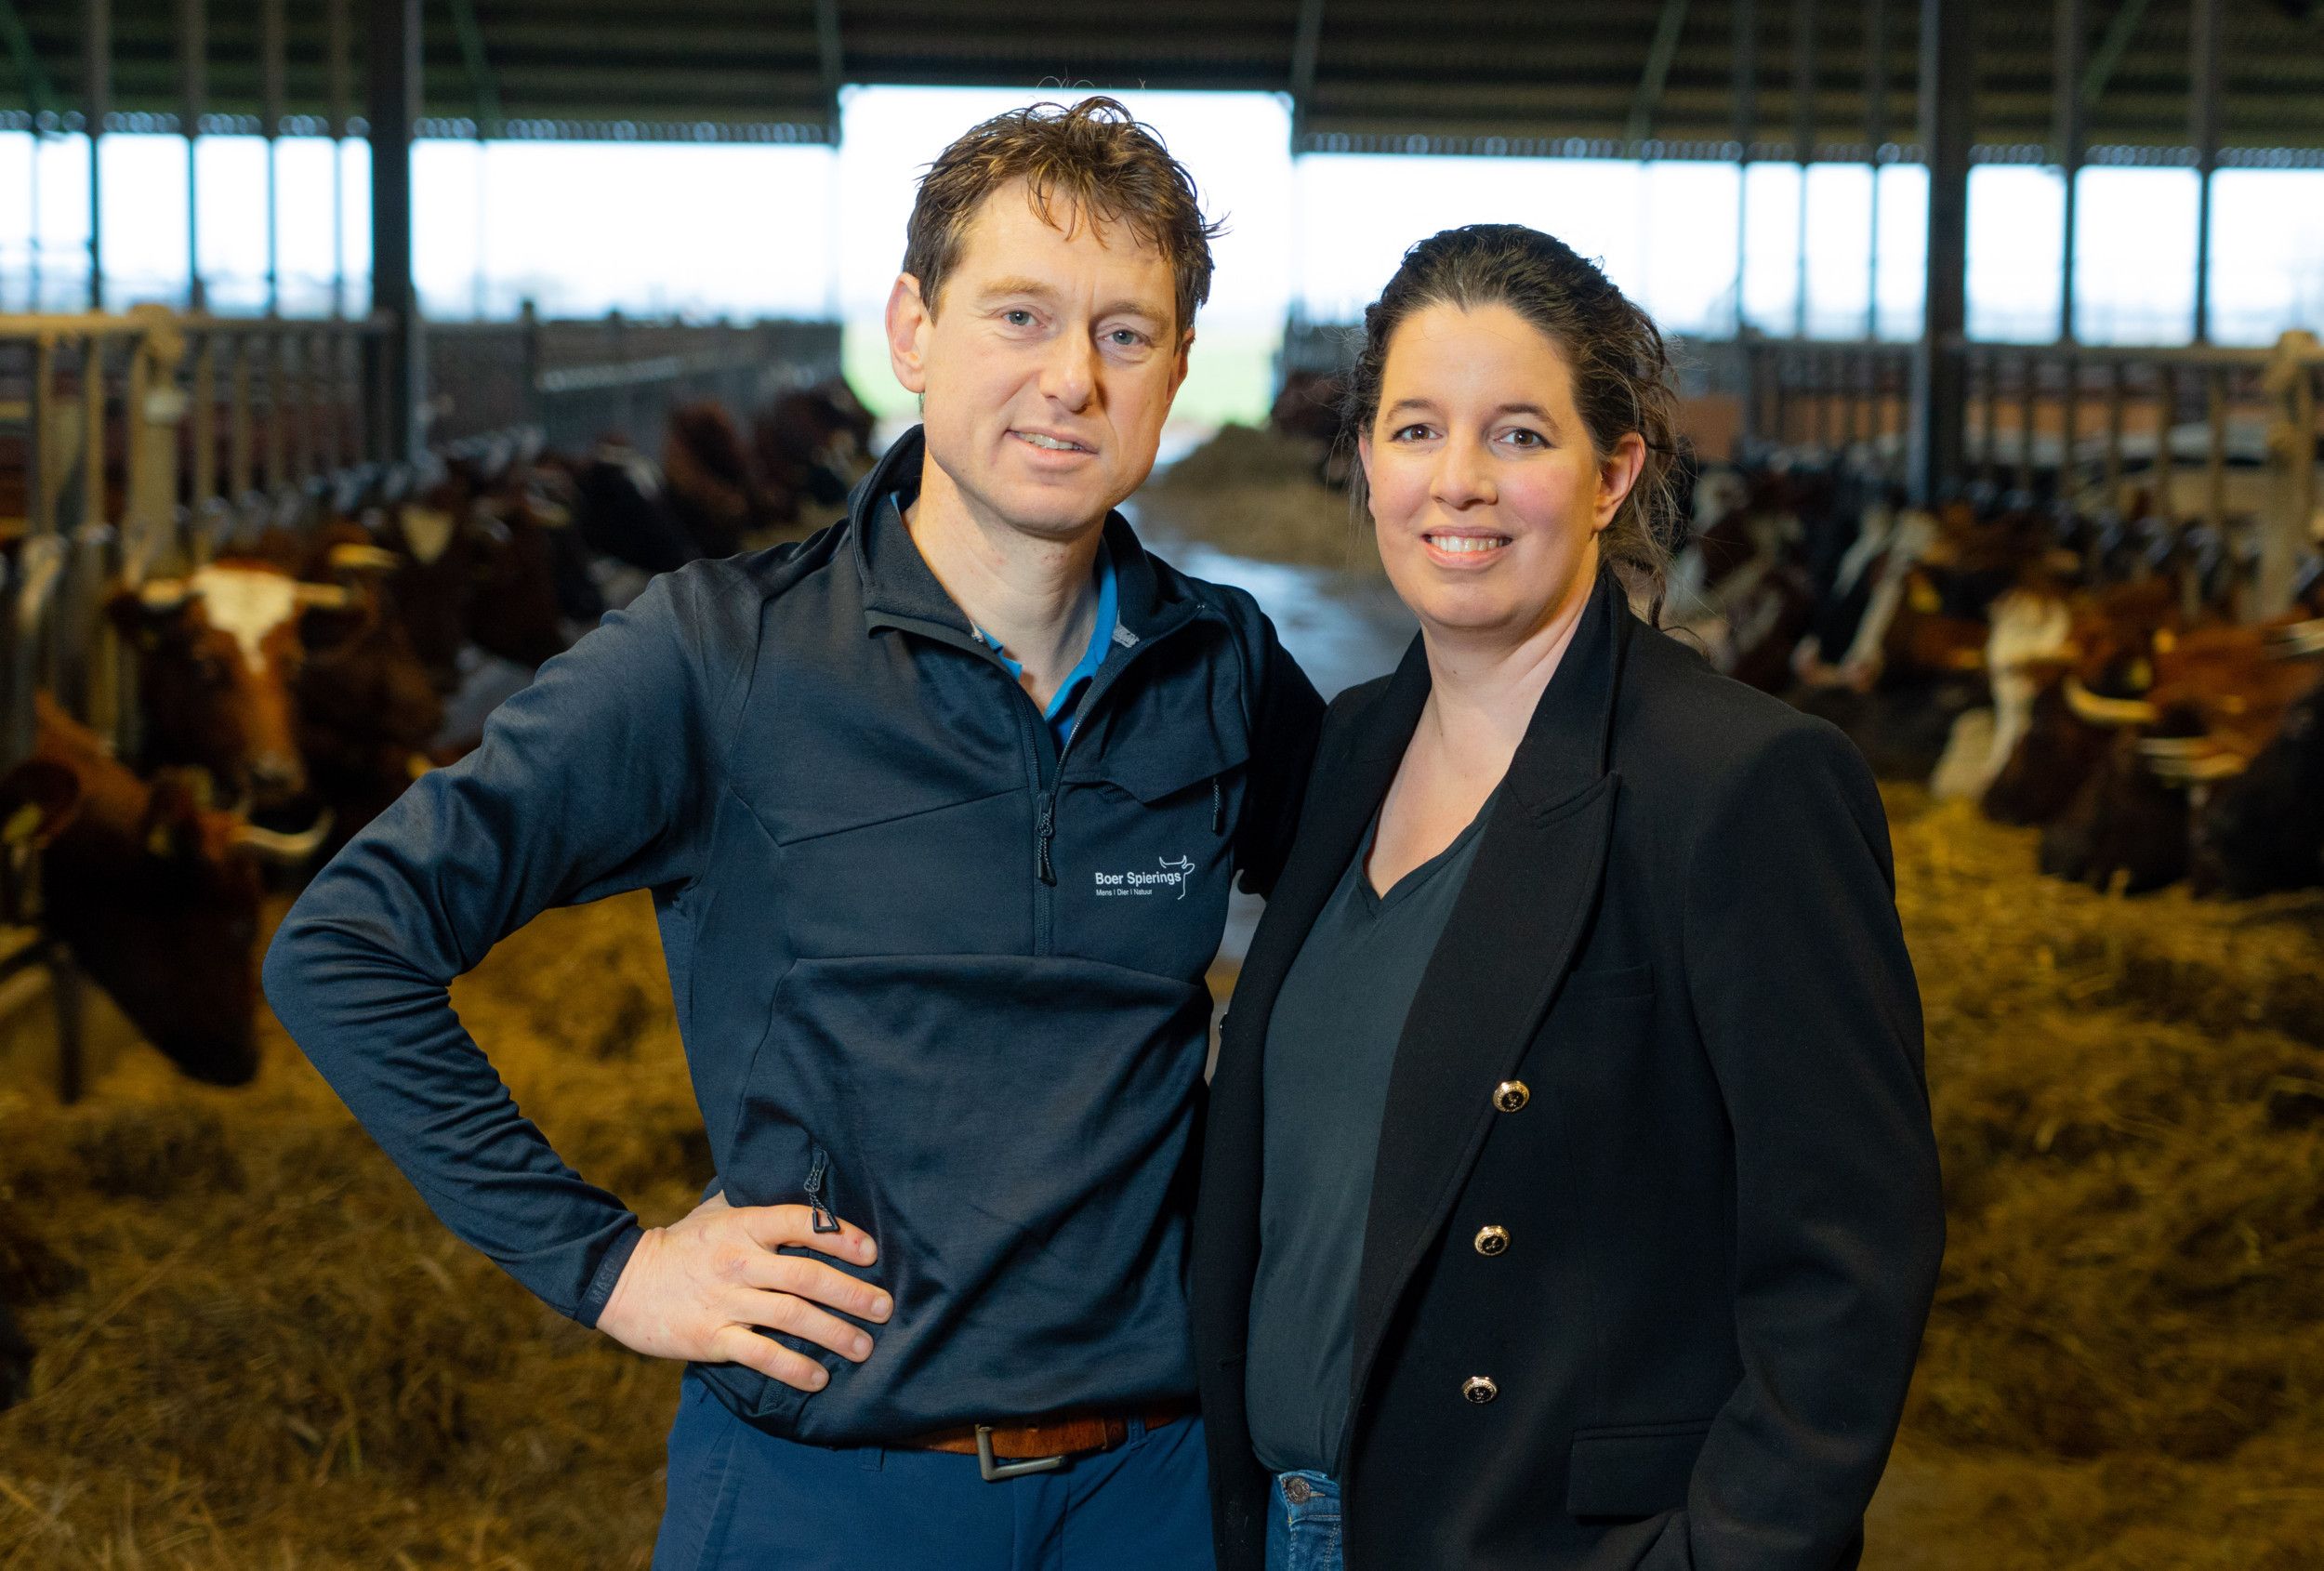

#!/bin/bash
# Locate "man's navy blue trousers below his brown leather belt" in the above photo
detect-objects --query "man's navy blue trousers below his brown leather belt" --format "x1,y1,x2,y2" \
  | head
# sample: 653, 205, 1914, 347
654, 1371, 1213, 1571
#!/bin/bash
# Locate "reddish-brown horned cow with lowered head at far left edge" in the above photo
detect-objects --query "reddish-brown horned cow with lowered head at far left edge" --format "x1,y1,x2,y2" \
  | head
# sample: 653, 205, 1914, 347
0, 693, 324, 1086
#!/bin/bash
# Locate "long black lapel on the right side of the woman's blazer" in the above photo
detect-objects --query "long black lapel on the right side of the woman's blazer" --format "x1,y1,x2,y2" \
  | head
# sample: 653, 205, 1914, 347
1348, 574, 1634, 1469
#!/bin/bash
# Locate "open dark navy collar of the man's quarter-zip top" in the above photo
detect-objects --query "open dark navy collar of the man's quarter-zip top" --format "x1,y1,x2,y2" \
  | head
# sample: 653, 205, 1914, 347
849, 426, 1204, 651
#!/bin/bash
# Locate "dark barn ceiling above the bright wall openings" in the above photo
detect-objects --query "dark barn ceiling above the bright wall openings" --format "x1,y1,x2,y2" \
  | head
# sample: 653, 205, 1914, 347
0, 0, 2324, 153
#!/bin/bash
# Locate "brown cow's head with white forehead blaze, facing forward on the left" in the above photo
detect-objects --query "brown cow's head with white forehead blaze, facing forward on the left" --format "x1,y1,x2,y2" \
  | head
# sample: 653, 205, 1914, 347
110, 556, 347, 812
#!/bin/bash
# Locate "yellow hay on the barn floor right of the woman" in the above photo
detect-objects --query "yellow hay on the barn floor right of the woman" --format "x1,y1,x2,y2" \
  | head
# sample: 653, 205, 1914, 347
1867, 790, 2324, 1571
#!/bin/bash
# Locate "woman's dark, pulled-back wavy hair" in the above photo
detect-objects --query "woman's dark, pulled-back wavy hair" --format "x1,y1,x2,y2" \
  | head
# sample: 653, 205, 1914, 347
1348, 223, 1678, 609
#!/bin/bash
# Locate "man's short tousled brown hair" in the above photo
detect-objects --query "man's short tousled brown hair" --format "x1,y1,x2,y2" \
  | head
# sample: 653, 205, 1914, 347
905, 98, 1222, 335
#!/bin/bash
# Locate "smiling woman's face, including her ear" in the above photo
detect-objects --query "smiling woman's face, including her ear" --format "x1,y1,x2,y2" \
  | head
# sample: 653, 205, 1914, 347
1360, 305, 1645, 646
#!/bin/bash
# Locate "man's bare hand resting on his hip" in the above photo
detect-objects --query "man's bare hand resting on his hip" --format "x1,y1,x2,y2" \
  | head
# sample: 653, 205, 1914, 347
598, 1190, 895, 1393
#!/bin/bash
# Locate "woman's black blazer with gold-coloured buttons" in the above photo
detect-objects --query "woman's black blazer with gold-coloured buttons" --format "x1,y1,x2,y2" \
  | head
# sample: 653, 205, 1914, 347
1193, 574, 1943, 1571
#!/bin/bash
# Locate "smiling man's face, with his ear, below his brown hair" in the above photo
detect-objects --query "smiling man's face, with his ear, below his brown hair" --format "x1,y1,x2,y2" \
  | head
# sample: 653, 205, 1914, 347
888, 181, 1195, 539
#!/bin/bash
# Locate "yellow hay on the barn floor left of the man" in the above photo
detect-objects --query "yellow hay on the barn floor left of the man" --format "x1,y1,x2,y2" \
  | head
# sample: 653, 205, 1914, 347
0, 897, 709, 1571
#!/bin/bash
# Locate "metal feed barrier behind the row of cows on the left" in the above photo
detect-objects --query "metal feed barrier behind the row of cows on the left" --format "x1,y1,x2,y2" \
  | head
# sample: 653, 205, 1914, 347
0, 307, 839, 1100
